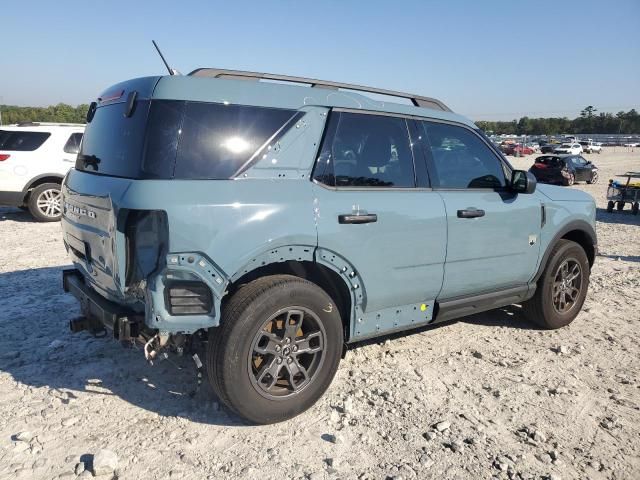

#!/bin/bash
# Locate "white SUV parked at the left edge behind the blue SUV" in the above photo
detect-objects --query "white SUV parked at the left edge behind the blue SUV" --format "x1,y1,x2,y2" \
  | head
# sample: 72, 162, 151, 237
0, 123, 84, 222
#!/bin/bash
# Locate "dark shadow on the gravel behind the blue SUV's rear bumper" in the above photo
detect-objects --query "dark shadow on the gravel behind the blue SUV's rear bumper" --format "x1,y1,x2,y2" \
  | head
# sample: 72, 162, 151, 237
0, 267, 245, 426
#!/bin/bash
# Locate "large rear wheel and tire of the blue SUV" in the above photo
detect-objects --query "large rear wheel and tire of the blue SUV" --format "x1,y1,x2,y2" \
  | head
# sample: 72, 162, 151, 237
207, 275, 343, 424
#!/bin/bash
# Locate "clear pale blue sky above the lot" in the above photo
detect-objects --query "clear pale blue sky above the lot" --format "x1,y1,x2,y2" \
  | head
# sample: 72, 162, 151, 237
0, 0, 640, 120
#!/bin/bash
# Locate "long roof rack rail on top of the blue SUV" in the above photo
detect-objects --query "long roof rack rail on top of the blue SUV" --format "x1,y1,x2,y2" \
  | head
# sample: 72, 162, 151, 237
189, 68, 451, 112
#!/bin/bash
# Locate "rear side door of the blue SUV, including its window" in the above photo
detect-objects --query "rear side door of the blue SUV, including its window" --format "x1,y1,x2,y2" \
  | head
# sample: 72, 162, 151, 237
314, 111, 446, 318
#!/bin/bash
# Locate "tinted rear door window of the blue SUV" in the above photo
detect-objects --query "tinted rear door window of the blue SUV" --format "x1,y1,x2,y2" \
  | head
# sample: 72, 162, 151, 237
315, 112, 415, 188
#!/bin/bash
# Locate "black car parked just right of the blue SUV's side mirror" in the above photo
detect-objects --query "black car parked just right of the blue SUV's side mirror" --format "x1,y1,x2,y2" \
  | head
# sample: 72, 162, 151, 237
529, 155, 598, 186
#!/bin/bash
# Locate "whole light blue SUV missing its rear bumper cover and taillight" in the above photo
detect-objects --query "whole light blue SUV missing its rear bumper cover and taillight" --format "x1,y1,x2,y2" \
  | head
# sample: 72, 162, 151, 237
62, 69, 597, 423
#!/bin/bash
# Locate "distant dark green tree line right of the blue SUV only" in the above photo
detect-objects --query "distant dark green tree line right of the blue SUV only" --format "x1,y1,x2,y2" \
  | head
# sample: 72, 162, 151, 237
476, 105, 640, 135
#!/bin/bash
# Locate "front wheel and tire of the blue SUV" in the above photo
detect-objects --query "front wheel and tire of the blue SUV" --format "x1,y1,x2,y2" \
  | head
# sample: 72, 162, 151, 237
522, 239, 590, 330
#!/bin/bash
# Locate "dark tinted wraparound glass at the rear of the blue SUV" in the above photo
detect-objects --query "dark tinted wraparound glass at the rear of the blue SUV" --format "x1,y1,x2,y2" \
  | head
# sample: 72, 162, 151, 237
76, 100, 301, 179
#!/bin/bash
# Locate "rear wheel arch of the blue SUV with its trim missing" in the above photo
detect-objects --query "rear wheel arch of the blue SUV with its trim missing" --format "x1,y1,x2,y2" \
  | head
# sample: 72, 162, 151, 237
225, 245, 362, 342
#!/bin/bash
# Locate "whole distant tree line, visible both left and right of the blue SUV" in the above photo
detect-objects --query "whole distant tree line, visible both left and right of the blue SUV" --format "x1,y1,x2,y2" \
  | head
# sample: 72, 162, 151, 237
0, 103, 640, 135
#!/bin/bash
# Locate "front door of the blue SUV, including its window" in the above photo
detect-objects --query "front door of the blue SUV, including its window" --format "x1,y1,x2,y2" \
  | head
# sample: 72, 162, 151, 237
420, 121, 542, 300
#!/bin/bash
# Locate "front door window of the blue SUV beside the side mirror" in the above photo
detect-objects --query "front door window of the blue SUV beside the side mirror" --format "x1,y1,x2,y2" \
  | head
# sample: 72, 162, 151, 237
421, 121, 506, 188
